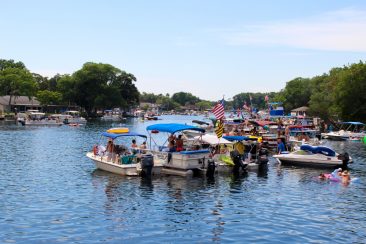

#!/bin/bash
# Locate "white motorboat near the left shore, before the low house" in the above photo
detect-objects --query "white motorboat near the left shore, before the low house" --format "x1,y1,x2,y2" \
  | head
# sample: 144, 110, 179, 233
18, 110, 63, 126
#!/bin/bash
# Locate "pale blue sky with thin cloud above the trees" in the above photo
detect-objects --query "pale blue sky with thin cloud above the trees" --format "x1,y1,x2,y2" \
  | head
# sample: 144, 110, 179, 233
0, 0, 366, 101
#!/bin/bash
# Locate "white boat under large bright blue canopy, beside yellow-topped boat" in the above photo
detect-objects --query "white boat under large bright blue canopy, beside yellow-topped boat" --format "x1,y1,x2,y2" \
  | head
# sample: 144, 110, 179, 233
146, 123, 210, 176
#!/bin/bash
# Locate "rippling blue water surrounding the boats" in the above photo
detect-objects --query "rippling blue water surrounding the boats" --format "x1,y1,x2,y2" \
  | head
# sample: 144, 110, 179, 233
0, 117, 366, 243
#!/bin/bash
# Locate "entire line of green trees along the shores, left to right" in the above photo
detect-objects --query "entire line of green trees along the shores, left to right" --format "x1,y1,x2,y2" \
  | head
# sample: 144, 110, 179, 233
0, 59, 366, 122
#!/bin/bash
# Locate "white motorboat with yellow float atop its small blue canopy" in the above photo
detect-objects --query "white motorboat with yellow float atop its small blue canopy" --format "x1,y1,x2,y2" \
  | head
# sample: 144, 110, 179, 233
86, 128, 162, 176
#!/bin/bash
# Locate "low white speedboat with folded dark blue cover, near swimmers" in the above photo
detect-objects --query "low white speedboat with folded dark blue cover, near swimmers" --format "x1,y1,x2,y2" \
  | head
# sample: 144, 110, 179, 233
273, 145, 352, 168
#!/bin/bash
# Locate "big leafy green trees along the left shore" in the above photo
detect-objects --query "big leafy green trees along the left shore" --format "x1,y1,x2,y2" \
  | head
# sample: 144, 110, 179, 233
0, 59, 139, 116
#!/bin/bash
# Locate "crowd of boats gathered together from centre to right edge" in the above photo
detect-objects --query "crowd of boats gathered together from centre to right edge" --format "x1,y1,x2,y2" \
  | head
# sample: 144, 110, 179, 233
87, 118, 365, 179
